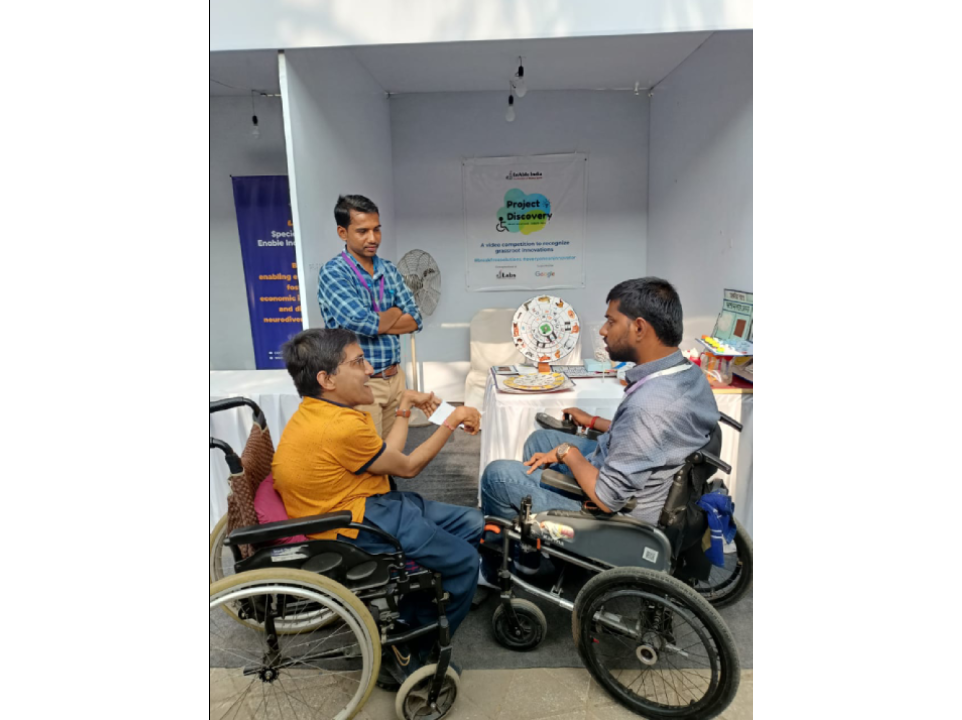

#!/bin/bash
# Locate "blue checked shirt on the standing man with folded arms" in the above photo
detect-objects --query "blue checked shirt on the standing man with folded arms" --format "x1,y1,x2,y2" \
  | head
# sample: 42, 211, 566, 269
317, 255, 423, 373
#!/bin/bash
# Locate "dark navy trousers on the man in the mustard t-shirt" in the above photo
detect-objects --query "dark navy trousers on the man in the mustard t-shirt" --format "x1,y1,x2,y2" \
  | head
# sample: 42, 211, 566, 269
345, 492, 484, 633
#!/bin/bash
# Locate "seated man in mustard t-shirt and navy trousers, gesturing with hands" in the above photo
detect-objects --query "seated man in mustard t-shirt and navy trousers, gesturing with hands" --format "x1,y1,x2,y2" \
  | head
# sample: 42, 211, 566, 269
273, 329, 484, 684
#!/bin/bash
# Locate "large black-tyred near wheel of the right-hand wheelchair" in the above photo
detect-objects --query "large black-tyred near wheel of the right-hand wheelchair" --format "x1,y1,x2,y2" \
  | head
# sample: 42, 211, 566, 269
572, 568, 741, 720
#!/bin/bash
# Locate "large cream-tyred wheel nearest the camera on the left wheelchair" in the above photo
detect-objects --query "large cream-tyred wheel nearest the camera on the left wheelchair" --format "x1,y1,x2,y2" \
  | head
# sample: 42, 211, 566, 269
210, 570, 381, 720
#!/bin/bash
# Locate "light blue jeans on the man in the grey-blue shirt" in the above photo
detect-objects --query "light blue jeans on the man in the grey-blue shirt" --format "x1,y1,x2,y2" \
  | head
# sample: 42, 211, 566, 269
481, 430, 598, 519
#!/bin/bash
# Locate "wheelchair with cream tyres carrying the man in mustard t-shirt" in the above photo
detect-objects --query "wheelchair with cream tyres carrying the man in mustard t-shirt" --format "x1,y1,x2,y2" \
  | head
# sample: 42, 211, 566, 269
210, 398, 460, 720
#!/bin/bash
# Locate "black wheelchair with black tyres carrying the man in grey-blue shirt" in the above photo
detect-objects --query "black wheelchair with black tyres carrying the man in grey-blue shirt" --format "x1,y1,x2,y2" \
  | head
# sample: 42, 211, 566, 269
482, 416, 753, 720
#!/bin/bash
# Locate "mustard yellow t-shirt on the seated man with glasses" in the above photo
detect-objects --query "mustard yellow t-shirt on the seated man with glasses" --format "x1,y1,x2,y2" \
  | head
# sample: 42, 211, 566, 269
273, 398, 391, 540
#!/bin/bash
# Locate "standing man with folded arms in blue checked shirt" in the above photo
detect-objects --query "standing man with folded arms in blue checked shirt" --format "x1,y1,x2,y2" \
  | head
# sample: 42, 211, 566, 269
317, 195, 423, 438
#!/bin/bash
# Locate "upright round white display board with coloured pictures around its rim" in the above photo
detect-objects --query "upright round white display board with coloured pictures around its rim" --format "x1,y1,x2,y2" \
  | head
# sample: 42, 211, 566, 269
511, 295, 581, 364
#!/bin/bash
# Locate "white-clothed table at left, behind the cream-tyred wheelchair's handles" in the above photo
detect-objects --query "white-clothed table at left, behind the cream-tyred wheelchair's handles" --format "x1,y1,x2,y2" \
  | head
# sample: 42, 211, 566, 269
210, 370, 301, 530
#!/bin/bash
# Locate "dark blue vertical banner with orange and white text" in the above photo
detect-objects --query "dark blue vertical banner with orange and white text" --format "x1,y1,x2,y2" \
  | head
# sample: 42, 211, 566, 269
232, 176, 303, 370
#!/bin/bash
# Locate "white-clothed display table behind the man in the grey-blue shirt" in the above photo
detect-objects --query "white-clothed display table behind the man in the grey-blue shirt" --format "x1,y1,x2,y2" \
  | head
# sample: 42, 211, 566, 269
481, 376, 755, 537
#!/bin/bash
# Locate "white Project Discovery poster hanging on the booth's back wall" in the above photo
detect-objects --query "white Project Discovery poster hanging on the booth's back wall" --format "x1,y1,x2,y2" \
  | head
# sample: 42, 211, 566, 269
462, 154, 588, 292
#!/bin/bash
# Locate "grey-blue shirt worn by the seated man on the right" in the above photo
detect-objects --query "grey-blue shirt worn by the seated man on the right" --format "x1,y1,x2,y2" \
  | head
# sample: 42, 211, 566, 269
588, 352, 721, 524
